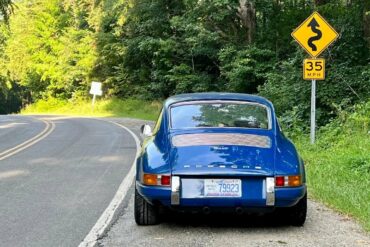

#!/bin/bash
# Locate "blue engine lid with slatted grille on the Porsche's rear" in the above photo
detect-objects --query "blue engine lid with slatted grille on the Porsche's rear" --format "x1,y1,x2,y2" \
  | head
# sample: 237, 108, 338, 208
170, 133, 274, 176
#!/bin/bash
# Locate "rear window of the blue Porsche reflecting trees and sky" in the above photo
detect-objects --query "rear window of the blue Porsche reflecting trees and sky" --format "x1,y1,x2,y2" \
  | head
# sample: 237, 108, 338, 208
171, 102, 270, 129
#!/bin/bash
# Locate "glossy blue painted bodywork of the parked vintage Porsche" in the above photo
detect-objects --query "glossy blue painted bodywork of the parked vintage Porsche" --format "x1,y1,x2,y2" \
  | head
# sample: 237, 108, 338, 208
136, 93, 306, 208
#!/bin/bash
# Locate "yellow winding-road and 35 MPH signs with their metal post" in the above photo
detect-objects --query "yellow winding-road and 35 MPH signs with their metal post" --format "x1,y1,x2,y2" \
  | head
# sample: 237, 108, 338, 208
292, 12, 339, 144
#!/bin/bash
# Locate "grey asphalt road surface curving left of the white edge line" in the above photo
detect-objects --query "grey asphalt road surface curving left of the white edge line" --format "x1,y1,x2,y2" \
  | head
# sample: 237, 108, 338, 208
0, 116, 136, 246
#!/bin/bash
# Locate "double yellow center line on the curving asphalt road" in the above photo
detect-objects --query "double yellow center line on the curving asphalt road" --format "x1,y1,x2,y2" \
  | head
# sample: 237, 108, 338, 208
0, 120, 55, 161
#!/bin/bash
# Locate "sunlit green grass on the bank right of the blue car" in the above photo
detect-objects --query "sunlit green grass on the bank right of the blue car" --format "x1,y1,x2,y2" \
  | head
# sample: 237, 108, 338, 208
294, 102, 370, 231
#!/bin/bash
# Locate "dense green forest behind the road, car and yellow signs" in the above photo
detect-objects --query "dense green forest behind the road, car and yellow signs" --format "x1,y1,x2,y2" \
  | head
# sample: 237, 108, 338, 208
0, 0, 370, 126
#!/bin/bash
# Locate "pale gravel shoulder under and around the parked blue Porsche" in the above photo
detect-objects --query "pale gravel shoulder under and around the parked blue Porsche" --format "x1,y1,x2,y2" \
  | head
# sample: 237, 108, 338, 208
99, 192, 370, 247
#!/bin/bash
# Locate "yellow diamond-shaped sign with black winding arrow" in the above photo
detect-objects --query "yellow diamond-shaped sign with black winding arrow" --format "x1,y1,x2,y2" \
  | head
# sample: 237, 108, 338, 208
292, 12, 339, 58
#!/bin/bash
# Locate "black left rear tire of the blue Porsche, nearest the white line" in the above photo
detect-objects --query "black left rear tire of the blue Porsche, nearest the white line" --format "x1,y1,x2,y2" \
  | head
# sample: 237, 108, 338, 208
135, 189, 159, 226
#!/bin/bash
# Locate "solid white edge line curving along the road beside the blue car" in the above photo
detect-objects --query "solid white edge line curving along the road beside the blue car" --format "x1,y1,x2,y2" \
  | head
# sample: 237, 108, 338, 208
79, 119, 140, 247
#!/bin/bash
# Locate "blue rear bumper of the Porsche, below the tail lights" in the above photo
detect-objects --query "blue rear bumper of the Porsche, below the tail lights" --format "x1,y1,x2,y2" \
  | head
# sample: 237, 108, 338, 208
136, 179, 306, 208
